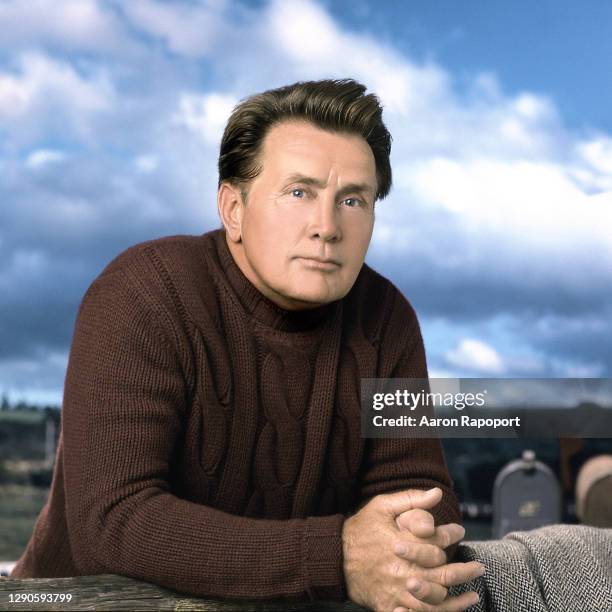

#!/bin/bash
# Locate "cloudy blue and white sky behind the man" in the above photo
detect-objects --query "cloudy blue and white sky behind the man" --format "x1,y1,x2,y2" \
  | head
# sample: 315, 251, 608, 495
0, 0, 612, 405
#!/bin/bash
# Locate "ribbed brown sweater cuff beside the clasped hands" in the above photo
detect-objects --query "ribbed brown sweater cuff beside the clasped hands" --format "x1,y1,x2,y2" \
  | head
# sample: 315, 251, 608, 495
302, 514, 347, 601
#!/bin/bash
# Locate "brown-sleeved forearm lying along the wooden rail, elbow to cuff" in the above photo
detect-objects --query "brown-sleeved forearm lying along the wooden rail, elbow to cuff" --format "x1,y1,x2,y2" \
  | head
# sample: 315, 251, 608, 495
69, 480, 345, 601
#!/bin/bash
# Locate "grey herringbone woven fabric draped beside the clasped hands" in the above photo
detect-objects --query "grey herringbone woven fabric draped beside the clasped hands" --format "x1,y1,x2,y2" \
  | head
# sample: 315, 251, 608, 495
449, 525, 612, 612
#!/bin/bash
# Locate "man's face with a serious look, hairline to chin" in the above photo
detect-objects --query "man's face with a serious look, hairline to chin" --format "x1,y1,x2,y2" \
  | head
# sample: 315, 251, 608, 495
229, 121, 377, 310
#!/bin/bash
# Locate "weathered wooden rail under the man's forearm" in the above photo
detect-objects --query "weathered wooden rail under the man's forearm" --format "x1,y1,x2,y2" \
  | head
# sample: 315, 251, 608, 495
0, 574, 365, 612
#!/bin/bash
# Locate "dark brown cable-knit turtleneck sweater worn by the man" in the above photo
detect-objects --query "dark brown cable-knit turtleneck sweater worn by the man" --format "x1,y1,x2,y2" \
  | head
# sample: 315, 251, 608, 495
11, 230, 460, 600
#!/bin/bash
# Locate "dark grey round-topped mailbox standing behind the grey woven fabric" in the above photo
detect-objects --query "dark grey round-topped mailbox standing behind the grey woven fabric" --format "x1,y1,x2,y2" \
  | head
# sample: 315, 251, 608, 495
493, 450, 561, 538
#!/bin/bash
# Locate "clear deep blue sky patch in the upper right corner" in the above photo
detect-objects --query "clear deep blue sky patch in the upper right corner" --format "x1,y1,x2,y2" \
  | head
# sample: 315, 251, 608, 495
324, 0, 612, 131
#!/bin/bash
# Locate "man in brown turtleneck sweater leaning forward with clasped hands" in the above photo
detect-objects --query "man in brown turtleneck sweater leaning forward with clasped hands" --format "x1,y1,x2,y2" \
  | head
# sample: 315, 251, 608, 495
12, 80, 482, 611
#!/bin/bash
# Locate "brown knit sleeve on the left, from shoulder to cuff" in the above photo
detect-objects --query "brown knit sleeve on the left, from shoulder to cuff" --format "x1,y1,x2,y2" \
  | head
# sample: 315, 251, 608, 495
62, 260, 346, 601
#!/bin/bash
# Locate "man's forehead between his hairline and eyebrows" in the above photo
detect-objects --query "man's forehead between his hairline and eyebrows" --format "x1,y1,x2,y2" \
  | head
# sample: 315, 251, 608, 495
261, 121, 376, 181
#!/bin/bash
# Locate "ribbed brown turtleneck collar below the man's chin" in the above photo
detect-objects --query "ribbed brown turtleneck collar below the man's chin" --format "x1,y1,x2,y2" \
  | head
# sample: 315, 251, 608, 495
211, 229, 339, 332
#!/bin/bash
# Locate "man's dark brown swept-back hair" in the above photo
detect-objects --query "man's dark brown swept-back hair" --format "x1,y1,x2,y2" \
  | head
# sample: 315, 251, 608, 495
219, 79, 391, 199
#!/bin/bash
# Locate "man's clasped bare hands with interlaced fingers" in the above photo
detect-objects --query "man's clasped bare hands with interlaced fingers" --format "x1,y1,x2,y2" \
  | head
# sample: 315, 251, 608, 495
342, 487, 484, 612
